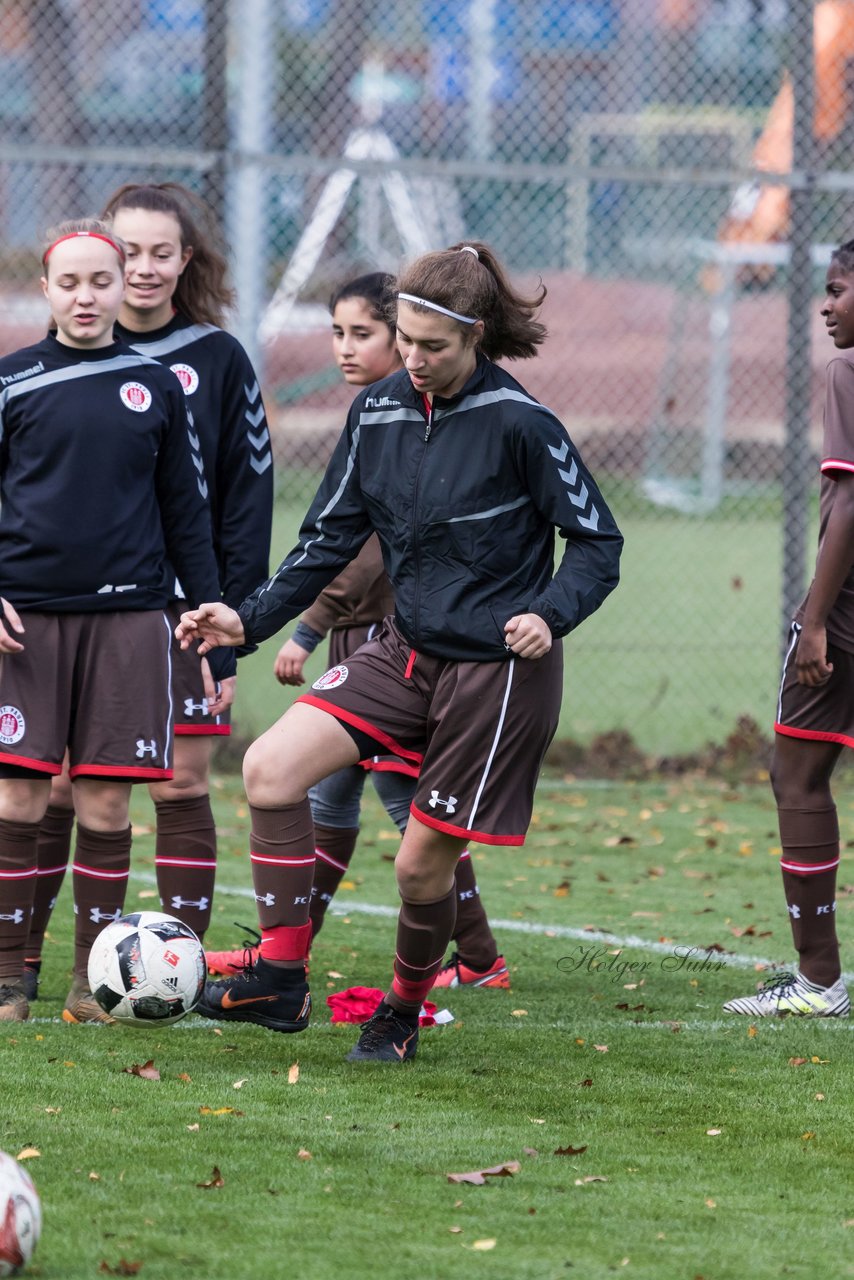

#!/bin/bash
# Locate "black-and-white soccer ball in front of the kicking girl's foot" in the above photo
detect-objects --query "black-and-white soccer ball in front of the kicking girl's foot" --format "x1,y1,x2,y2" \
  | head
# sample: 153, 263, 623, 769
88, 911, 207, 1027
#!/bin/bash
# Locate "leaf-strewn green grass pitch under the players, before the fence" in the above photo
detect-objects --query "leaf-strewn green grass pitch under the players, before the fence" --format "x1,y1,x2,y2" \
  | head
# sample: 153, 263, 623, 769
0, 777, 854, 1280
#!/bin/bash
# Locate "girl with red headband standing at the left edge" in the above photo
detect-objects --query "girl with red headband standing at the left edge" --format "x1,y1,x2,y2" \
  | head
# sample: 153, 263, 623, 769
0, 219, 234, 1021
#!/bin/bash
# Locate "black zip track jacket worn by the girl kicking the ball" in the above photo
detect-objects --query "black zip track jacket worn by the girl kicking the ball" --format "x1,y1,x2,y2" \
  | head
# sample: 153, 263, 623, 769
238, 356, 622, 662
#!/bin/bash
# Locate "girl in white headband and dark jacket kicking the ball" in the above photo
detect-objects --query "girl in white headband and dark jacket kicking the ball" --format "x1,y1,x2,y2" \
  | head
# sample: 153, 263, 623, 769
178, 244, 622, 1062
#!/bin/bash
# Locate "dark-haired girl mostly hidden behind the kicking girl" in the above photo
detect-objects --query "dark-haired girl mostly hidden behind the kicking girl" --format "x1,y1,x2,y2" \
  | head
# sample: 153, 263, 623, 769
207, 271, 510, 989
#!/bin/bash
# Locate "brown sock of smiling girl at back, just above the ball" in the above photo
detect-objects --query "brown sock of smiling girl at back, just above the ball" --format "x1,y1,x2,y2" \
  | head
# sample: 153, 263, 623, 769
154, 795, 216, 938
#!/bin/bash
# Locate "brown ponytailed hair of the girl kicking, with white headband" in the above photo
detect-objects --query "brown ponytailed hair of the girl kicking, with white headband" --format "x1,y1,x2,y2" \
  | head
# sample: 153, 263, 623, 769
393, 241, 548, 360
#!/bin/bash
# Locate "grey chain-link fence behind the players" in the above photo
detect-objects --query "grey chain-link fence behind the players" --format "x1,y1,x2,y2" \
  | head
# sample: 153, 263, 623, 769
0, 0, 854, 754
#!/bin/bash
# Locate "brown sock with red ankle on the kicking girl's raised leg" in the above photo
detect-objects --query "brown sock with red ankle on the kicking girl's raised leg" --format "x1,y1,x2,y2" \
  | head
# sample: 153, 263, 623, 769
250, 796, 315, 969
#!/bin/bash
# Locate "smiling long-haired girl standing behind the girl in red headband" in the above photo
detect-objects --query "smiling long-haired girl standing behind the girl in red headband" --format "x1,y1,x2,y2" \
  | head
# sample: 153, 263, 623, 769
20, 182, 273, 996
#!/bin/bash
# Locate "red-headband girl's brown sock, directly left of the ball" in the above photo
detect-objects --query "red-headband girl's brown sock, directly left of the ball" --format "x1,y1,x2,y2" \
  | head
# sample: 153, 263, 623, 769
72, 822, 131, 980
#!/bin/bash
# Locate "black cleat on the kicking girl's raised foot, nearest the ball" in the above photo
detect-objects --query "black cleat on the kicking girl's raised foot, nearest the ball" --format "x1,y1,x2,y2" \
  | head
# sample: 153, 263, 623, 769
195, 959, 311, 1032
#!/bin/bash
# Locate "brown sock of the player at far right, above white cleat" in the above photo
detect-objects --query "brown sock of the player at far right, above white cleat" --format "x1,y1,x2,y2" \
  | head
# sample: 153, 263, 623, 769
778, 805, 841, 987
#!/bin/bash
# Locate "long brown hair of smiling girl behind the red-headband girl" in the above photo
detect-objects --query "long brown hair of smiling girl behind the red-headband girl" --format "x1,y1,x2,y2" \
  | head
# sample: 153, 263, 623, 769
101, 182, 234, 326
